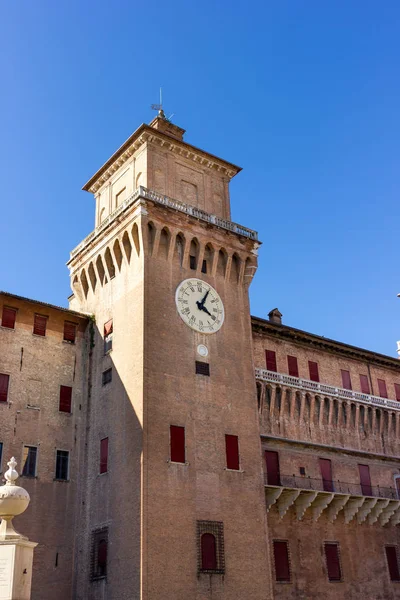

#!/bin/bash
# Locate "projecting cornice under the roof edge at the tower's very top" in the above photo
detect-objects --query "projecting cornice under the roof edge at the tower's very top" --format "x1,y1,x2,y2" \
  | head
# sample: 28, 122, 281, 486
82, 123, 241, 194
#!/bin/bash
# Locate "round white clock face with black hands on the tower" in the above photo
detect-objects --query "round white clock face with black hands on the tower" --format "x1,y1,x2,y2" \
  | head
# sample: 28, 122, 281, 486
175, 277, 225, 333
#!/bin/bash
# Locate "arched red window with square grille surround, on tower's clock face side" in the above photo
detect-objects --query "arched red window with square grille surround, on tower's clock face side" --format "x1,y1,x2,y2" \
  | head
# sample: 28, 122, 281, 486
197, 521, 225, 575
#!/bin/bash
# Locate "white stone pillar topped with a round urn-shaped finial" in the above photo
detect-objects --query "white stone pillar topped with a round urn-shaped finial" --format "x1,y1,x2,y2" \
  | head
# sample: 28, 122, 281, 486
0, 458, 37, 600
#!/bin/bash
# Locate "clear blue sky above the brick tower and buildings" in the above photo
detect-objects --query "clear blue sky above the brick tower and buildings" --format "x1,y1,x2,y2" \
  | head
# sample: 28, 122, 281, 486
0, 0, 400, 355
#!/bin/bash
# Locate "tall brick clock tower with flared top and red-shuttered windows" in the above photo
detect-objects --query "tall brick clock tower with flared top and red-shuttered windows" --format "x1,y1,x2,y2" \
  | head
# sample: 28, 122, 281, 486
68, 111, 271, 600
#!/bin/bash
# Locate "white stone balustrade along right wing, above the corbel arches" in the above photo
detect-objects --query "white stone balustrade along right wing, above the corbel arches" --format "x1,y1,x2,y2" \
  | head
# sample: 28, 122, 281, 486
255, 368, 400, 410
